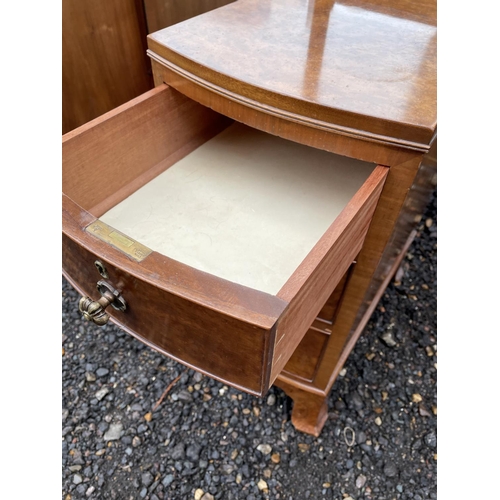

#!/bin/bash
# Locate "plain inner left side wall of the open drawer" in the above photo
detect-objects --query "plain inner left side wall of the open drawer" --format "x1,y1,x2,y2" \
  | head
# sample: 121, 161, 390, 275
62, 85, 231, 217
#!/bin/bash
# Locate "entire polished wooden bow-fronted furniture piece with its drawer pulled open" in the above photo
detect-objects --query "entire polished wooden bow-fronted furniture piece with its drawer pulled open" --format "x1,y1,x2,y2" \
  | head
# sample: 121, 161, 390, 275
63, 0, 436, 435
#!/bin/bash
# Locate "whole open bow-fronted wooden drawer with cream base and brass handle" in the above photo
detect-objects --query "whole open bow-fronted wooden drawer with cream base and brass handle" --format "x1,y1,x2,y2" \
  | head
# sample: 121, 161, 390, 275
62, 85, 388, 395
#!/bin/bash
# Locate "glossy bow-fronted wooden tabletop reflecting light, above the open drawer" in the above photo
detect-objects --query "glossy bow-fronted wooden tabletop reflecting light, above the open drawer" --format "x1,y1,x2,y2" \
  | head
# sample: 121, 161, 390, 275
148, 0, 437, 149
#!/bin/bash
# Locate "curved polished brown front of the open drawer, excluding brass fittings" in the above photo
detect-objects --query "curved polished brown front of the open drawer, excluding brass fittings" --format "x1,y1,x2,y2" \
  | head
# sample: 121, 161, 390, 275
63, 197, 287, 395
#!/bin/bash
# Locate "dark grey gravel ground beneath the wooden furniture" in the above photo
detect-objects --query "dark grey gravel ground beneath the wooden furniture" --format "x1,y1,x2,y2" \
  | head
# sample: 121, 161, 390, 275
62, 191, 437, 500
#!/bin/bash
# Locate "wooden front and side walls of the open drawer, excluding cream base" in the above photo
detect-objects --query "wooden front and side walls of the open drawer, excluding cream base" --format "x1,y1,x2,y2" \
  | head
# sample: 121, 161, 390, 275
63, 85, 388, 395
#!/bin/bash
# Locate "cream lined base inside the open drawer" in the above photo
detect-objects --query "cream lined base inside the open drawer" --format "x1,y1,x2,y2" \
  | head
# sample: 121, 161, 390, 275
100, 123, 375, 295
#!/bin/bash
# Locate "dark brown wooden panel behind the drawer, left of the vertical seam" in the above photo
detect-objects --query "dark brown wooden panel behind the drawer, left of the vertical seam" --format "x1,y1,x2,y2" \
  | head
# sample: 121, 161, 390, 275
62, 0, 153, 134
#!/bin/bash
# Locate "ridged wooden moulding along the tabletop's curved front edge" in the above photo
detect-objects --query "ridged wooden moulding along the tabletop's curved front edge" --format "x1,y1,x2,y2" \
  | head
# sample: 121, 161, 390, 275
147, 50, 435, 153
